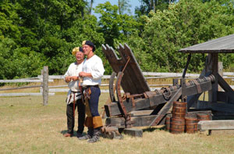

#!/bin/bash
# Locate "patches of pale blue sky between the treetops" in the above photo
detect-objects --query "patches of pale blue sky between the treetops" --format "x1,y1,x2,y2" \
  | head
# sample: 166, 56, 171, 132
92, 0, 141, 15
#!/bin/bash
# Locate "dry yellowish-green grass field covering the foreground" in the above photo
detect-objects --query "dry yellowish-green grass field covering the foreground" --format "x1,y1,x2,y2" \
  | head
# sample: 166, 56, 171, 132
0, 93, 234, 154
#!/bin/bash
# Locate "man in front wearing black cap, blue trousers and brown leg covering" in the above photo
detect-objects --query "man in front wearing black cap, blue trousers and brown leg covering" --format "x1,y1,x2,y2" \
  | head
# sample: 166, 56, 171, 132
79, 41, 105, 143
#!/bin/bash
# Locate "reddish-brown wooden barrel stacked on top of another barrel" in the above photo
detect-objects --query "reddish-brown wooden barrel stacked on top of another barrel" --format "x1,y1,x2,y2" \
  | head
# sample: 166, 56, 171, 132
172, 102, 187, 118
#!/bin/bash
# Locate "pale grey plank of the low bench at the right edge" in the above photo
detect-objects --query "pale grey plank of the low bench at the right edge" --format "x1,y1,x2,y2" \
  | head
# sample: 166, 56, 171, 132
198, 120, 234, 131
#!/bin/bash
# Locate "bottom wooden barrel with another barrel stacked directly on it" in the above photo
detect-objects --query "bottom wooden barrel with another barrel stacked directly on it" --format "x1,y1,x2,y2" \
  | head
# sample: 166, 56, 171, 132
170, 117, 185, 134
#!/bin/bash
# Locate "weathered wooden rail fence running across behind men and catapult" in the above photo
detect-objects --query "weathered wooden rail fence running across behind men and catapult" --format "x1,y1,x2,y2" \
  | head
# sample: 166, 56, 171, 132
0, 66, 234, 105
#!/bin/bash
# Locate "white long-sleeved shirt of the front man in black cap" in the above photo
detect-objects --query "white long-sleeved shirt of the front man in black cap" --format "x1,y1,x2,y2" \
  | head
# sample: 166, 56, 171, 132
82, 55, 105, 87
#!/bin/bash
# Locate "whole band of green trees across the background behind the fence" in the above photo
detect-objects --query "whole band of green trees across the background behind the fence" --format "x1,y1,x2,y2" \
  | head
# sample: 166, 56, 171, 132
0, 0, 234, 79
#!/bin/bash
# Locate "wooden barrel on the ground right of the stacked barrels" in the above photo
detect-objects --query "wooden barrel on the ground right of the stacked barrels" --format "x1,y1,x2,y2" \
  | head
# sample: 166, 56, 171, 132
185, 116, 198, 134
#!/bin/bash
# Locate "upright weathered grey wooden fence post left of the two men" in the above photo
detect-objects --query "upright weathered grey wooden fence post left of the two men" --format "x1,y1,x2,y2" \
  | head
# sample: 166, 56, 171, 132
42, 66, 49, 105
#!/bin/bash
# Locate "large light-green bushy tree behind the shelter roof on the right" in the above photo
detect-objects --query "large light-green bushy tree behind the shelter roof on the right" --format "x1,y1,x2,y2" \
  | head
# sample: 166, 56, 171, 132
130, 0, 234, 72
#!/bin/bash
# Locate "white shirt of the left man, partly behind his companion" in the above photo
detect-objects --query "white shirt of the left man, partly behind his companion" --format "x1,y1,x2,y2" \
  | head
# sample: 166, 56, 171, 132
64, 62, 83, 92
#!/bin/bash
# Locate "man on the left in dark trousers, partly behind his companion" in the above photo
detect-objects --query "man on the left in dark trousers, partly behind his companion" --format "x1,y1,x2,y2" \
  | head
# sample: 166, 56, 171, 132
64, 47, 85, 137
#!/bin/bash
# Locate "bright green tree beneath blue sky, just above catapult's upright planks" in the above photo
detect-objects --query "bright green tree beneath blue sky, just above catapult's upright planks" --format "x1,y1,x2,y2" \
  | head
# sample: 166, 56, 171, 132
95, 2, 139, 47
